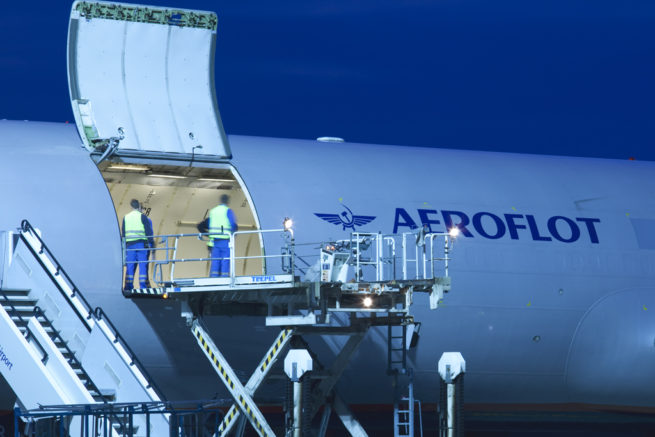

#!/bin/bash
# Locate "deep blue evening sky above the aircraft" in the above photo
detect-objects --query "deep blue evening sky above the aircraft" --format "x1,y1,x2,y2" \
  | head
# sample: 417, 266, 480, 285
0, 0, 655, 160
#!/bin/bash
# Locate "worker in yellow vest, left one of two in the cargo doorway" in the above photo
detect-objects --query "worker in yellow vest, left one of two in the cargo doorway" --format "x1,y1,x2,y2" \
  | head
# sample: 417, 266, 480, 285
122, 199, 155, 290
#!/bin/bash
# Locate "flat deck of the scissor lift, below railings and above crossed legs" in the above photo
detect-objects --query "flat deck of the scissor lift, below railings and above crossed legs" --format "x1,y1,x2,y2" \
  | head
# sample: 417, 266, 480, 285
125, 275, 450, 321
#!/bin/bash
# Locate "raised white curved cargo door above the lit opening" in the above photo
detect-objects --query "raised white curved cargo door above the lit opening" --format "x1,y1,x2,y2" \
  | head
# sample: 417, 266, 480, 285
68, 1, 231, 161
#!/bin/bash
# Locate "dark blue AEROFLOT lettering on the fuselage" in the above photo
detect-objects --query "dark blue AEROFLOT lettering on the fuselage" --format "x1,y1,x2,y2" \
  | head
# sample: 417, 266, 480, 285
393, 208, 600, 244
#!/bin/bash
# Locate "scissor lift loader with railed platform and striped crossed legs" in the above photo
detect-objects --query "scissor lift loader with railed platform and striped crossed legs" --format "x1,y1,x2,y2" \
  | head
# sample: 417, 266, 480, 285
125, 229, 452, 436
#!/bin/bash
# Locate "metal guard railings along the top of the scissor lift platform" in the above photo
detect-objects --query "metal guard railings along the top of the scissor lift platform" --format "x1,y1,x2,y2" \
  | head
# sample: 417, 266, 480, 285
123, 228, 455, 286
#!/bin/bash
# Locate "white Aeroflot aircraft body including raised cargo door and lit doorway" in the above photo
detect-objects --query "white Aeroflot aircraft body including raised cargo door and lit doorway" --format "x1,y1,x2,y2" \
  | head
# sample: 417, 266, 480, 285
0, 3, 655, 424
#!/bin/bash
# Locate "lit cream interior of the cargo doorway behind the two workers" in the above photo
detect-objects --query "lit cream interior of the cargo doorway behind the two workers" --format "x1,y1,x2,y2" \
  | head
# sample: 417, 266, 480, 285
98, 161, 264, 281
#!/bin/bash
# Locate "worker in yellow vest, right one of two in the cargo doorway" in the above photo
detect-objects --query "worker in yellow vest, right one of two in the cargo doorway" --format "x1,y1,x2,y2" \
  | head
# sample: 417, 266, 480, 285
198, 194, 239, 278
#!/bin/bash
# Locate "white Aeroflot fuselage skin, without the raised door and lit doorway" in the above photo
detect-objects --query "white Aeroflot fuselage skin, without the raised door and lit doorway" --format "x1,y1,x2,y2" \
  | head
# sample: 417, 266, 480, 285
0, 121, 655, 406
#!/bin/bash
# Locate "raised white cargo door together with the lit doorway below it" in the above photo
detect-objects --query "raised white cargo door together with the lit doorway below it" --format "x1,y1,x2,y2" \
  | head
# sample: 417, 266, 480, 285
67, 1, 264, 281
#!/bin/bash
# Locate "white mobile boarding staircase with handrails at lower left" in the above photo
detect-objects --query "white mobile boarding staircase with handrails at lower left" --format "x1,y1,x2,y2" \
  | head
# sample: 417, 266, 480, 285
0, 220, 169, 437
